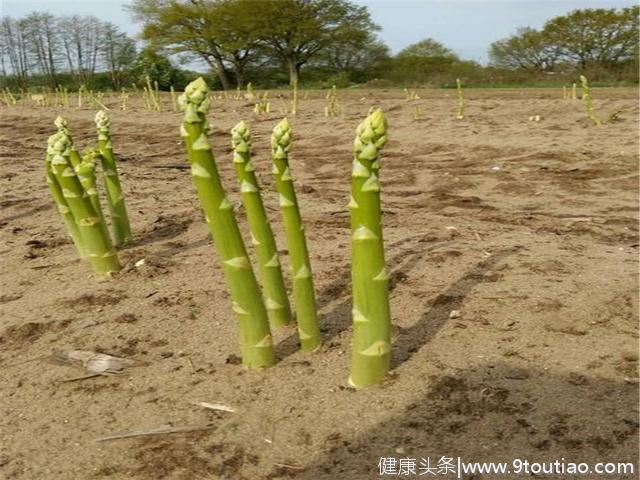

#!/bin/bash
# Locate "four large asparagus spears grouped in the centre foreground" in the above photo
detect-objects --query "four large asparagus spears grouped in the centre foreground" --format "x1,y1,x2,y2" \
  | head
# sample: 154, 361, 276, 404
180, 78, 391, 387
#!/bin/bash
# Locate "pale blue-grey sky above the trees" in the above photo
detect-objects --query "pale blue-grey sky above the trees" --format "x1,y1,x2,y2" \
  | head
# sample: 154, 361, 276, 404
0, 0, 637, 63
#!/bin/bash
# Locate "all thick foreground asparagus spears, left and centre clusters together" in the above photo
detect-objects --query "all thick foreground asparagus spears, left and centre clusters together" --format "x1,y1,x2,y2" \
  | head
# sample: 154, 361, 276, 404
47, 78, 391, 387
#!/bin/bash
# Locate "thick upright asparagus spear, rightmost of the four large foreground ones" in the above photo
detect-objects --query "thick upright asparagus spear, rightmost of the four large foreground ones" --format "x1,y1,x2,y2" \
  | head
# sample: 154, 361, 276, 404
349, 109, 391, 387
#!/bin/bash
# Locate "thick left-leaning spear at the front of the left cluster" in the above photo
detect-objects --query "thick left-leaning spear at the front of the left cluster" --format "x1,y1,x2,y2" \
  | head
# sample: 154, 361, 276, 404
47, 131, 120, 275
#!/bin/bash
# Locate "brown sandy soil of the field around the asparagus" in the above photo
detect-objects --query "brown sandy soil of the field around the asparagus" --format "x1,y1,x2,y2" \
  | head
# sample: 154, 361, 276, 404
0, 89, 638, 480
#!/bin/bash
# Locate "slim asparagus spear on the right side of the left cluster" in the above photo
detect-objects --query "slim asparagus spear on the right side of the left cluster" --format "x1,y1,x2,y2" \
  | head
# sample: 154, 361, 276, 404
95, 110, 133, 246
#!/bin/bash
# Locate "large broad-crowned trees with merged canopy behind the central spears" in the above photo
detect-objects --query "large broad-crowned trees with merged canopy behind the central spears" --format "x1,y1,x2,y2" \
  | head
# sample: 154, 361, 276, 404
128, 0, 379, 88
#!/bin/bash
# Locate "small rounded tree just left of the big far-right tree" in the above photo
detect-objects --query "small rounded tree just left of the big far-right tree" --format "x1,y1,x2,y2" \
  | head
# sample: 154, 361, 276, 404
489, 27, 561, 72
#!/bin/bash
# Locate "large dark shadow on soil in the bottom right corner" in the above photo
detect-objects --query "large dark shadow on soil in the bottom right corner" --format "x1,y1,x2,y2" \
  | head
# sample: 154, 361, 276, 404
292, 363, 638, 480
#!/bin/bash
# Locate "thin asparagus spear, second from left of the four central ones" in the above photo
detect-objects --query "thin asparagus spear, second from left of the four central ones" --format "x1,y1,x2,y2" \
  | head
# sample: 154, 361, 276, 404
231, 122, 291, 327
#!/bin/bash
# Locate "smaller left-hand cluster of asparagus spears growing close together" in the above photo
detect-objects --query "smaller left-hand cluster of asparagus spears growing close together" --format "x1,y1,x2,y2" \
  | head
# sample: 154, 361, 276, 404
45, 111, 132, 275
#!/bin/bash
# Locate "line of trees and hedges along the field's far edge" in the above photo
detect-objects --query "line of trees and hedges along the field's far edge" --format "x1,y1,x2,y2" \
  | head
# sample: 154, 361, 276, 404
0, 0, 640, 89
